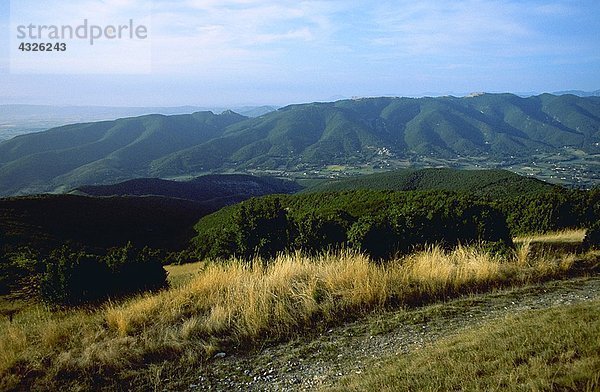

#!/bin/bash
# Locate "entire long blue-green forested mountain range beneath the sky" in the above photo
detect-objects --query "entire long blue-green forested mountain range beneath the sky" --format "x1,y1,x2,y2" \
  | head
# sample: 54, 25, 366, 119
0, 93, 600, 195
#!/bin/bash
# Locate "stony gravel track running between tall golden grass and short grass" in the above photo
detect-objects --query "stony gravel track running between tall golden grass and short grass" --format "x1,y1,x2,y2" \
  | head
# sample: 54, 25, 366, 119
177, 276, 600, 391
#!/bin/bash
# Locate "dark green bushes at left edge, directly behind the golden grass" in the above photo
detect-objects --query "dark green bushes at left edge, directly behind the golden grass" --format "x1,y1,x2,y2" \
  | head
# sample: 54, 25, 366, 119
0, 243, 167, 306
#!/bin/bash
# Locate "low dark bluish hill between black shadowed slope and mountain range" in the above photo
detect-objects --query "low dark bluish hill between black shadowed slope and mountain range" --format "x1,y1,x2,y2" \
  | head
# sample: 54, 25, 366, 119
71, 174, 300, 207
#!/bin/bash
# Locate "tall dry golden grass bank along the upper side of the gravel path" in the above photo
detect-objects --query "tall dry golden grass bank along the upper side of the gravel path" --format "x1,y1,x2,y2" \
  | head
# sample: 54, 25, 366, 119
0, 247, 596, 389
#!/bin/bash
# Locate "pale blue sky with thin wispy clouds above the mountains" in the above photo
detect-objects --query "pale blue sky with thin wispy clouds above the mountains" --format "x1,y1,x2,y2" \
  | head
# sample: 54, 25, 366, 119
0, 0, 600, 106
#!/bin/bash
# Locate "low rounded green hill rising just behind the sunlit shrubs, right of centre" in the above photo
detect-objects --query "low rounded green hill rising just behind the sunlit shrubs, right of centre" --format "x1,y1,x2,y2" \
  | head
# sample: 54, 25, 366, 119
304, 169, 557, 198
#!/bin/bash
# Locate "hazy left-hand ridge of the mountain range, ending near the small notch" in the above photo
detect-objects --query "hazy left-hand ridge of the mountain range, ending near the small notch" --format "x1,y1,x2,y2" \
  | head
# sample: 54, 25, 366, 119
0, 112, 245, 195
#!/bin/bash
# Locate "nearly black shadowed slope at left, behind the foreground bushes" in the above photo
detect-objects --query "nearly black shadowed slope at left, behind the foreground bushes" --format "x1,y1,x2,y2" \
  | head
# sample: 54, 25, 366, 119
0, 195, 215, 251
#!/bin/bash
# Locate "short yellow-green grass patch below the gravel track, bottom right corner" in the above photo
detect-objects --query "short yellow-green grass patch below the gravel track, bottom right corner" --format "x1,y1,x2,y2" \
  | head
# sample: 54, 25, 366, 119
331, 301, 600, 392
